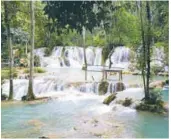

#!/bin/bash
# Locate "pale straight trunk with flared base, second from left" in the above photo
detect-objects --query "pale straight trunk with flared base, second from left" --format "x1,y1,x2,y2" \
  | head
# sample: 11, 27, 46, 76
26, 1, 35, 100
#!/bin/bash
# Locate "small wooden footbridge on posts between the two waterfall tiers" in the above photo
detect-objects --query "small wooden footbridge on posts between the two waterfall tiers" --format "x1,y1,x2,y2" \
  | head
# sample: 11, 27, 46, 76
87, 65, 124, 81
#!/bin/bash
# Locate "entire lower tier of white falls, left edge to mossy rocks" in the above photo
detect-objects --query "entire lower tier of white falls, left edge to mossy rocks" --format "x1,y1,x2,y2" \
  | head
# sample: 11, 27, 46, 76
2, 77, 99, 100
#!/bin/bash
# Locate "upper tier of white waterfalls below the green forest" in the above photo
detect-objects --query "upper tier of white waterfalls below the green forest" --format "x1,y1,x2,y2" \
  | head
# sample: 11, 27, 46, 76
34, 46, 165, 68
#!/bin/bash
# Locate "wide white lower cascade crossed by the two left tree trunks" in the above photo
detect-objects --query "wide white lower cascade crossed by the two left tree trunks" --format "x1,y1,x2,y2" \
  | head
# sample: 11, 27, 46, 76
2, 79, 64, 100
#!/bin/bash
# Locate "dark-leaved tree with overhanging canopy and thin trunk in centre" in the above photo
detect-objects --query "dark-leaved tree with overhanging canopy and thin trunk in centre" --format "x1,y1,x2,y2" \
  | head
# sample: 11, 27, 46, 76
44, 1, 111, 79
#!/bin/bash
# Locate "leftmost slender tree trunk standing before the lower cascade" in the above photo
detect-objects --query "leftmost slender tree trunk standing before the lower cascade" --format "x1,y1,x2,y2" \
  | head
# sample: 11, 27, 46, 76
4, 1, 13, 100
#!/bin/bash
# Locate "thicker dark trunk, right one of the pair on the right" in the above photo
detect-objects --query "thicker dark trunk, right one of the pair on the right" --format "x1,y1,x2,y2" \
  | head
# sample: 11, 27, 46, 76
146, 1, 151, 99
